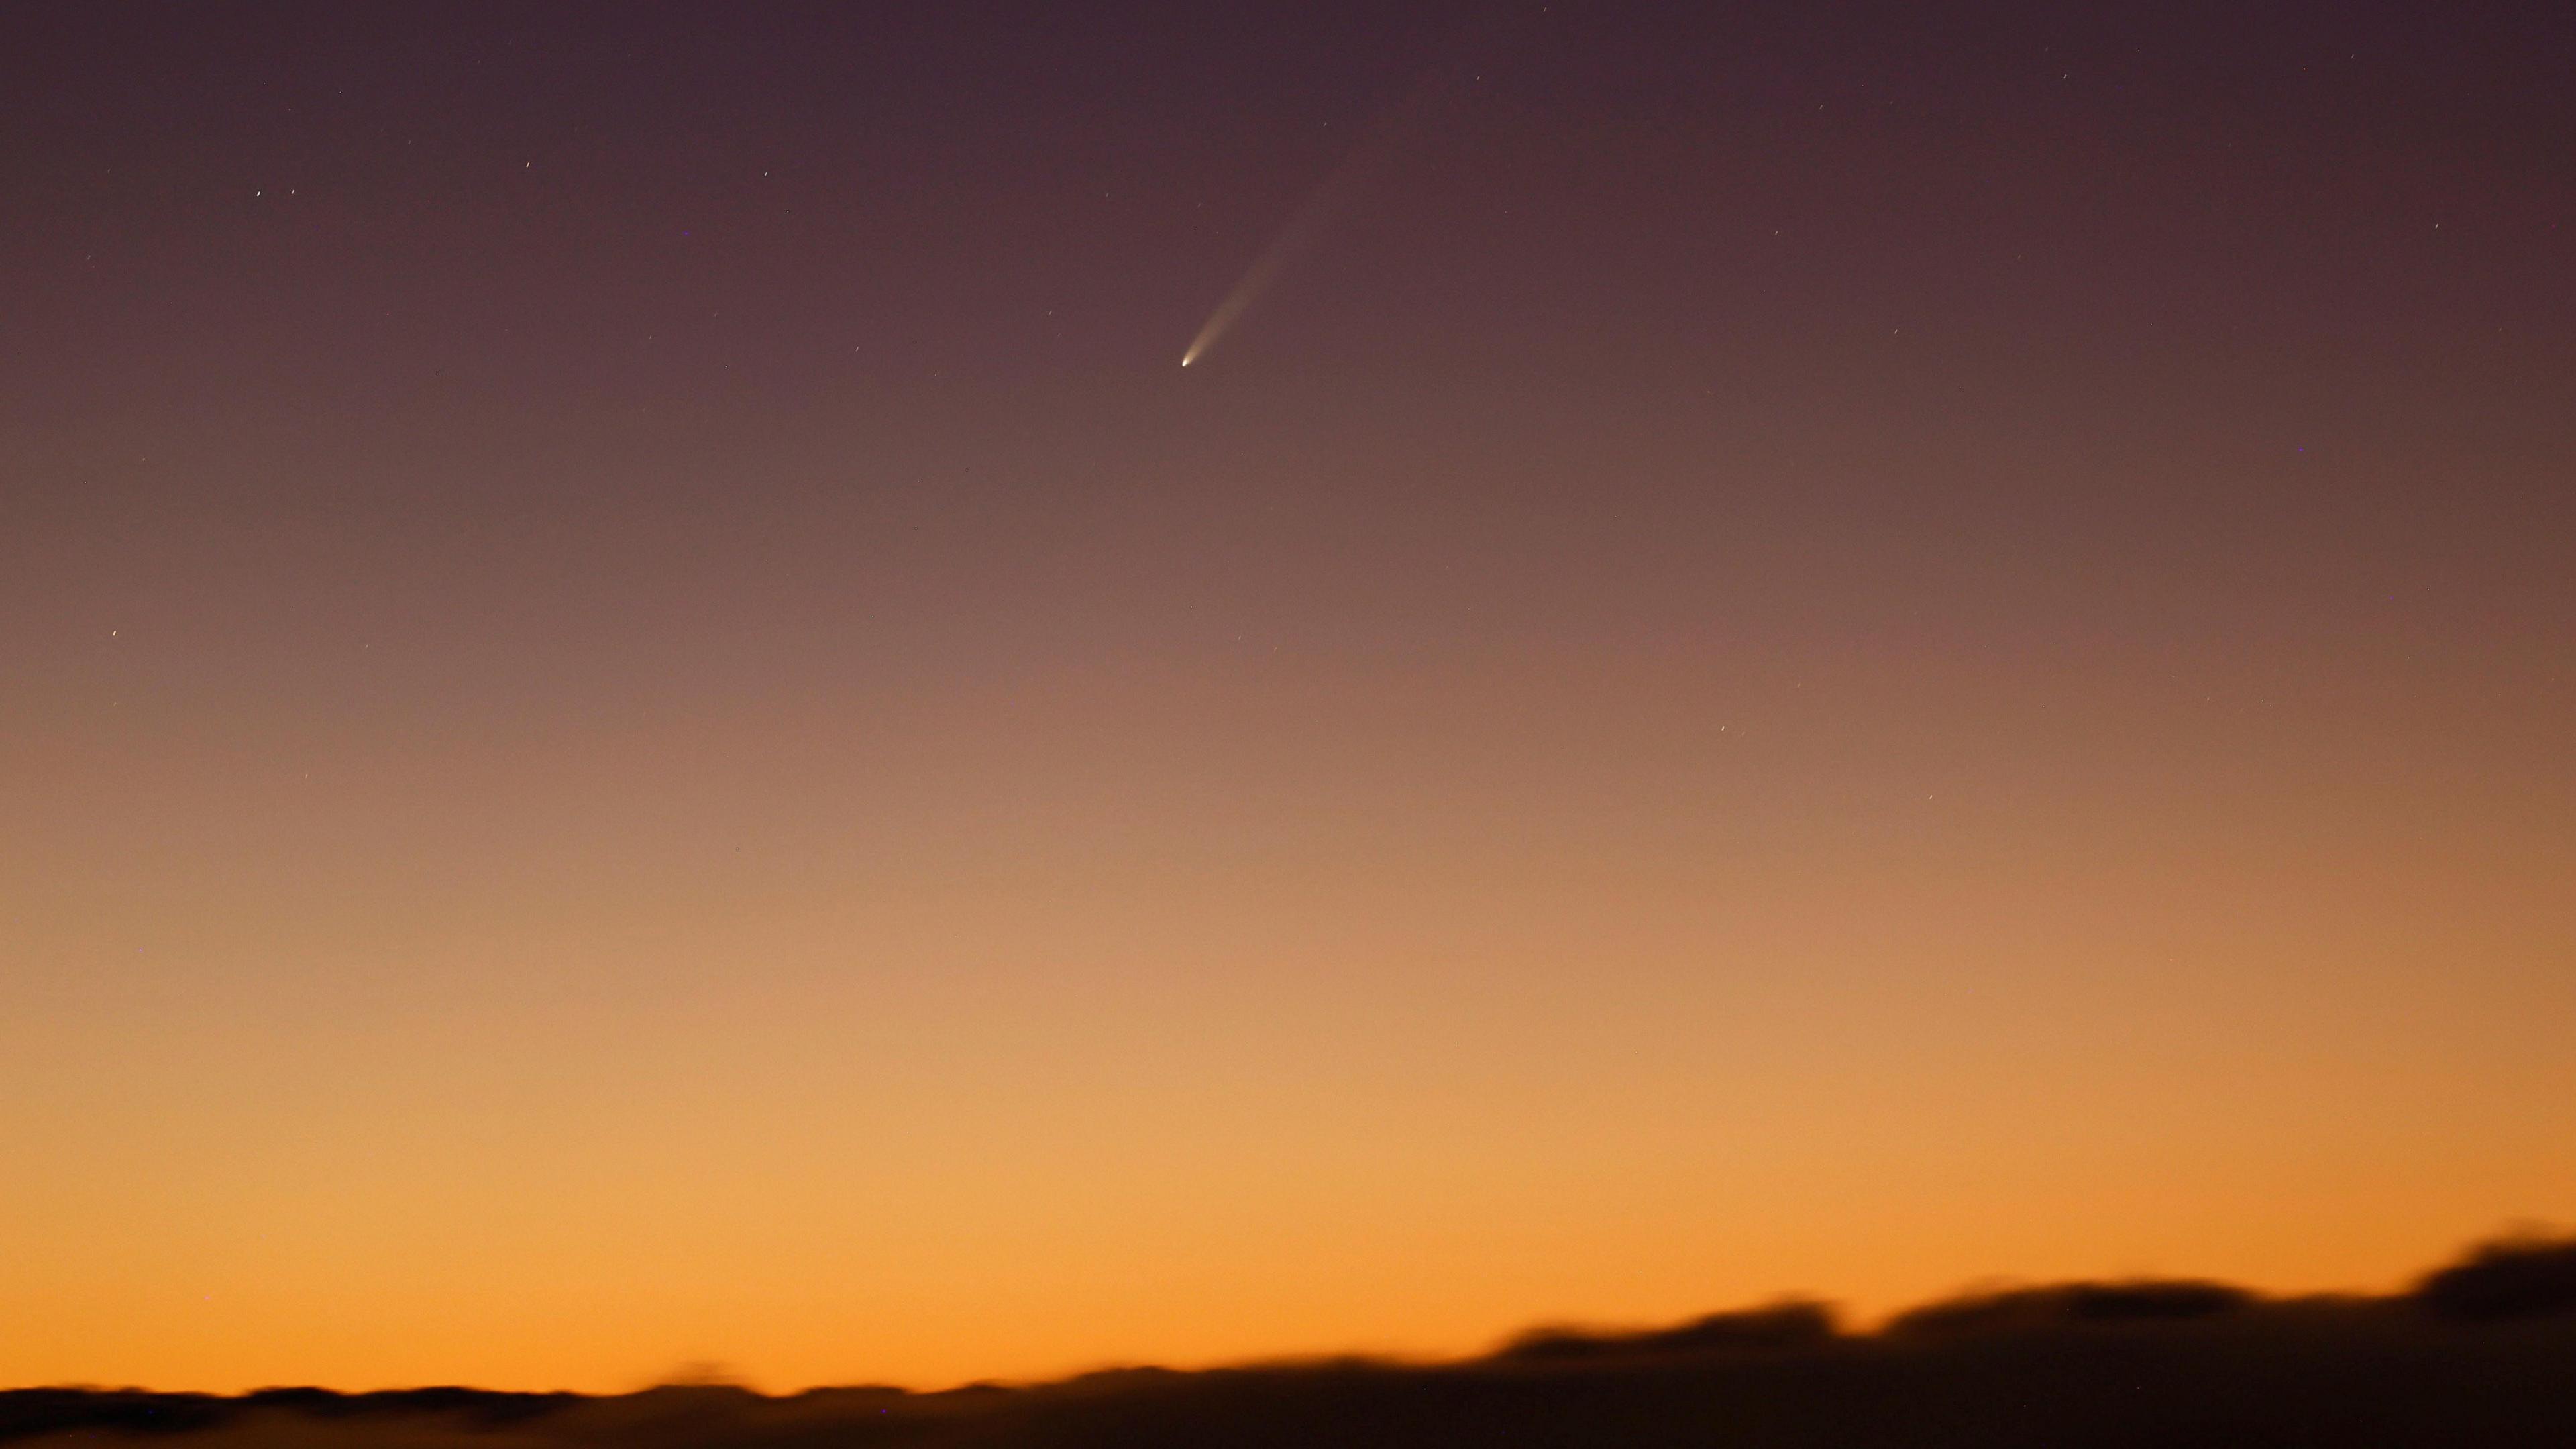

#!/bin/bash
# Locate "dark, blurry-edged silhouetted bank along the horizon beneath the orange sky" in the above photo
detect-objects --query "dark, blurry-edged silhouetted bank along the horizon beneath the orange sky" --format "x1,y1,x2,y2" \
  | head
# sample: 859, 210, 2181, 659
20, 1238, 2576, 1449
